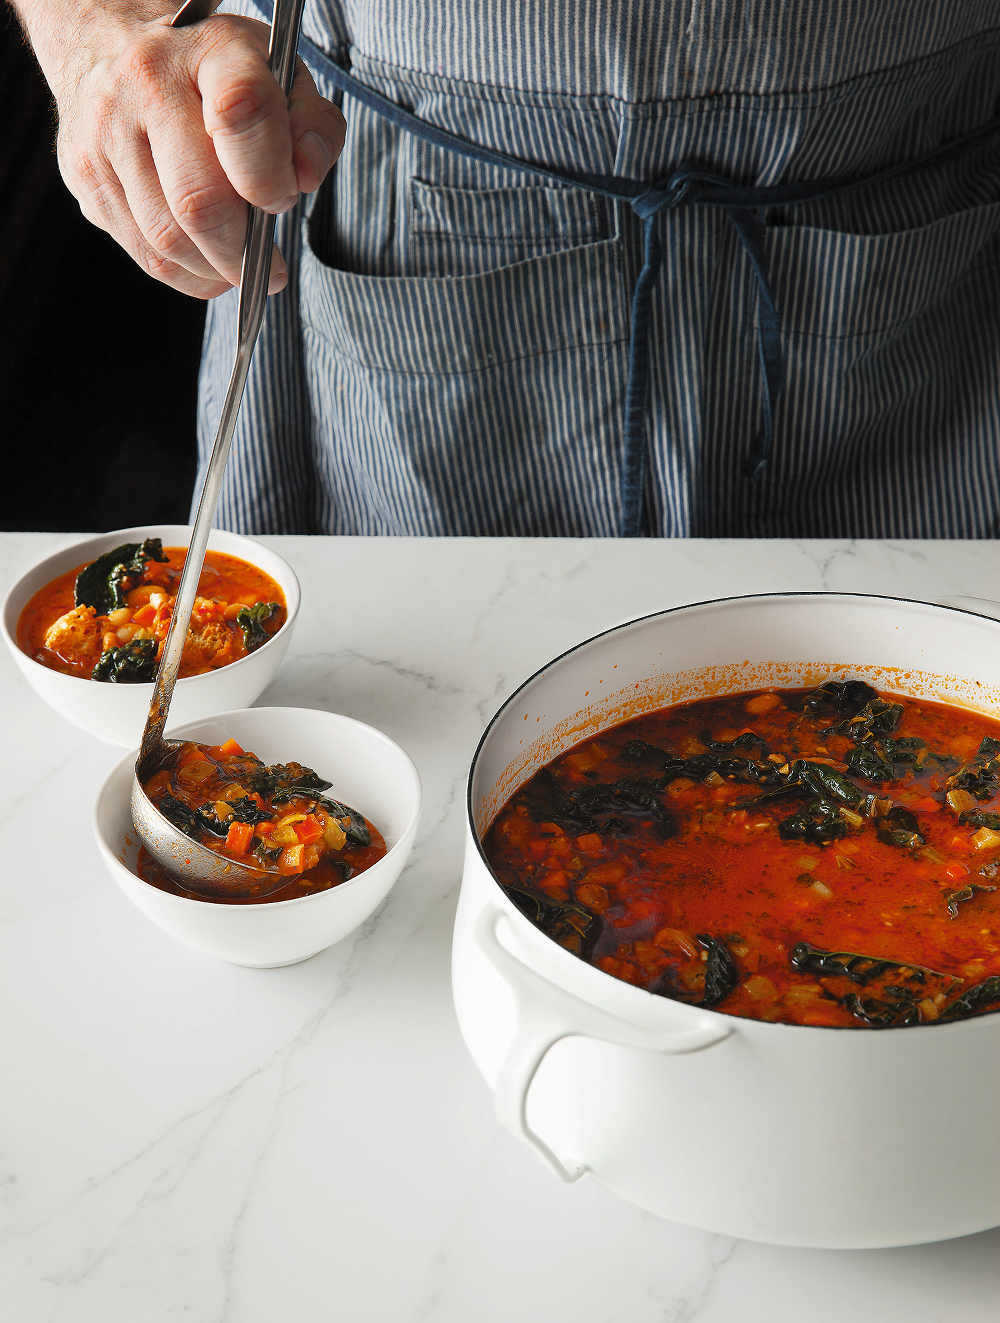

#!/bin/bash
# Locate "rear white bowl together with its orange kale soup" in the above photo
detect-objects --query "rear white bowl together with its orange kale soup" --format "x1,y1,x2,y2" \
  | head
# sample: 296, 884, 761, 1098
3, 525, 300, 747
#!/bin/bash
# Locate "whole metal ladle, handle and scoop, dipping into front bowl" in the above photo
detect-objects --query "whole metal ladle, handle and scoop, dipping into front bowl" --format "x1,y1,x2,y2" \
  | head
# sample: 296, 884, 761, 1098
131, 0, 304, 898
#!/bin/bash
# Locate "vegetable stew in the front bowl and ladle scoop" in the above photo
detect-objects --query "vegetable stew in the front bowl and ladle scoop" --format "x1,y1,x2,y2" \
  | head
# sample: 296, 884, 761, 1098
139, 740, 386, 901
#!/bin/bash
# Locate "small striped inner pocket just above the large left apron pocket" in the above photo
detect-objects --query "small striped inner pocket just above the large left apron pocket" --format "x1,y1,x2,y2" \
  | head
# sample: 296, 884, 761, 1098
407, 179, 612, 275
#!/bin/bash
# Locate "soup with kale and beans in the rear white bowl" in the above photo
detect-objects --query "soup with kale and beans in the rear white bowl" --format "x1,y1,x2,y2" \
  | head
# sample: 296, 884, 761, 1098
17, 537, 286, 684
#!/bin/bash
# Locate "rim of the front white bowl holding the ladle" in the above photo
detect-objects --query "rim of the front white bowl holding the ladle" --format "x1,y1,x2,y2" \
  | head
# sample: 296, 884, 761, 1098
90, 705, 422, 913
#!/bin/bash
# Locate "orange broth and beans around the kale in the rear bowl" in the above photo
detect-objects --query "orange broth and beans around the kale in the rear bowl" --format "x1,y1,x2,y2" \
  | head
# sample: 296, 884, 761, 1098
17, 546, 286, 679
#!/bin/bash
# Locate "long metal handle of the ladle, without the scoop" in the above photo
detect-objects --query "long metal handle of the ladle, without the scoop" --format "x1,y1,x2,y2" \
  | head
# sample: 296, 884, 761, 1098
136, 0, 304, 771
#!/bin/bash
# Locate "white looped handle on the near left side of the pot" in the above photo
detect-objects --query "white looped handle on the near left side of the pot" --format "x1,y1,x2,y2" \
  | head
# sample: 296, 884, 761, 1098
474, 909, 733, 1181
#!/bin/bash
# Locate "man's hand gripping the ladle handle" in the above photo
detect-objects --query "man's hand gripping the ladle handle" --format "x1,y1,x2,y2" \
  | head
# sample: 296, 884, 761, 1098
17, 0, 344, 299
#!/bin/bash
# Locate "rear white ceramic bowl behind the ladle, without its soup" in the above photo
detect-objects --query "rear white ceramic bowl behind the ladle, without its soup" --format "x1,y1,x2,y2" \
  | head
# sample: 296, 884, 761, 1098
0, 524, 302, 749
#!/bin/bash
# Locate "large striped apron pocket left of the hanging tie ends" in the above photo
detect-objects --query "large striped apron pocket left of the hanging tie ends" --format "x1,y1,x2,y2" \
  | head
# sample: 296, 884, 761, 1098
300, 216, 628, 536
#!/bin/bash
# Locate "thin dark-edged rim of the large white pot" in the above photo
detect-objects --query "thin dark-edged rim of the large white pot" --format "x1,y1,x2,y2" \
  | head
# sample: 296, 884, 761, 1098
466, 589, 1000, 1041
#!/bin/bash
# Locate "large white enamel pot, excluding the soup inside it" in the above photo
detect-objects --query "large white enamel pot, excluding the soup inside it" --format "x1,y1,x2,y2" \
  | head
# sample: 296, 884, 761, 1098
452, 593, 1000, 1248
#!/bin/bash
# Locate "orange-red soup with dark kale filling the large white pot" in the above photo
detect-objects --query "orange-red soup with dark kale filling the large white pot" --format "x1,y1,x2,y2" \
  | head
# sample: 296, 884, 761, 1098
484, 681, 1000, 1028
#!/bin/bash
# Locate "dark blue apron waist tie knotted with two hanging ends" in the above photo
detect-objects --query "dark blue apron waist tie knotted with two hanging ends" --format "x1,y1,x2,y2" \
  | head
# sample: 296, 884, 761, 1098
263, 0, 1000, 537
